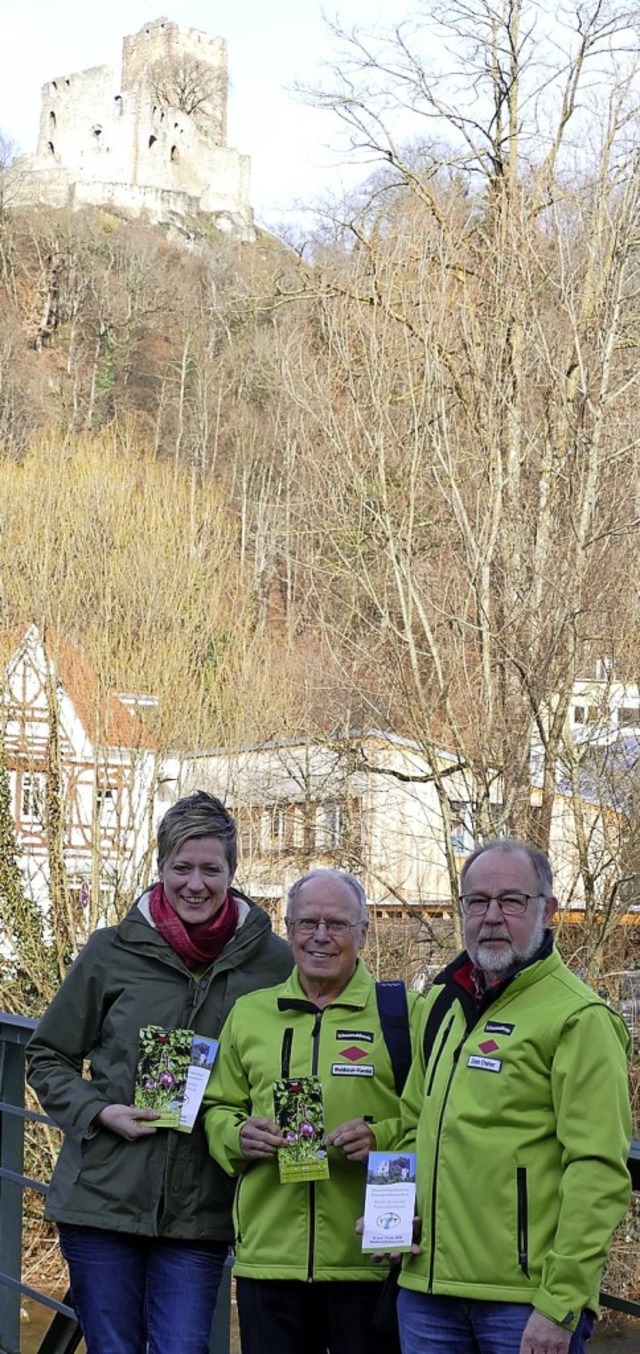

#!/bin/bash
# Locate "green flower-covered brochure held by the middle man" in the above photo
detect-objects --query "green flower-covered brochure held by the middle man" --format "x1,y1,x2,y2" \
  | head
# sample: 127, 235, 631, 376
273, 1076, 329, 1185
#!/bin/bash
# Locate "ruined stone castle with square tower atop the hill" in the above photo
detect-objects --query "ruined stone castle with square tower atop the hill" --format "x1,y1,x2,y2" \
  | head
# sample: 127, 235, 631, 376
12, 18, 254, 241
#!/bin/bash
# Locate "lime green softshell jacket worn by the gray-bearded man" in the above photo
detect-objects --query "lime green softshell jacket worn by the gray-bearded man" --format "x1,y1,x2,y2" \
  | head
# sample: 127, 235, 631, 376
401, 949, 631, 1328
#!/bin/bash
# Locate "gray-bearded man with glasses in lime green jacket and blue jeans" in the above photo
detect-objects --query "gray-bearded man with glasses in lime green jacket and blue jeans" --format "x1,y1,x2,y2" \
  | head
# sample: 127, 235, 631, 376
398, 838, 631, 1354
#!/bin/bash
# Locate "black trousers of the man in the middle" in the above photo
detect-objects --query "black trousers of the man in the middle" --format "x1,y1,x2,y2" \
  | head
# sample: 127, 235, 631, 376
235, 1278, 383, 1354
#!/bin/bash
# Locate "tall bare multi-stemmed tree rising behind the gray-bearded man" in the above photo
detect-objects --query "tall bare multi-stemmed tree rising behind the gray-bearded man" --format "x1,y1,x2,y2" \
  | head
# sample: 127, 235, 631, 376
283, 3, 640, 942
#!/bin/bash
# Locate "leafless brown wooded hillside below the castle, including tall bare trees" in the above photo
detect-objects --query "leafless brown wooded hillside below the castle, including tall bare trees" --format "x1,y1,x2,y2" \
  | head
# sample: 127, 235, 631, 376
0, 3, 640, 963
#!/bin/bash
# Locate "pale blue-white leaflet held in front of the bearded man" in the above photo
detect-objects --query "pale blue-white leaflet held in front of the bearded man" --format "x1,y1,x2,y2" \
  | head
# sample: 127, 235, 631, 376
363, 1152, 415, 1251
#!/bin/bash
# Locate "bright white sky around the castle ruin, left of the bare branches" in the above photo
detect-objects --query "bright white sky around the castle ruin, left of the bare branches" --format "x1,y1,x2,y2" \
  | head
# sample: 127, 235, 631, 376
0, 0, 407, 226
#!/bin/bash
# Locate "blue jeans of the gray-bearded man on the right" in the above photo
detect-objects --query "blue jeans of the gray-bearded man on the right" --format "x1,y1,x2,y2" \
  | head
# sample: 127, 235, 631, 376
398, 1288, 594, 1354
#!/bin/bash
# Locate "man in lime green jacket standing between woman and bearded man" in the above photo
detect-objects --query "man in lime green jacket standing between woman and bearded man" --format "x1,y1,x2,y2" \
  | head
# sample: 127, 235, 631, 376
204, 869, 425, 1354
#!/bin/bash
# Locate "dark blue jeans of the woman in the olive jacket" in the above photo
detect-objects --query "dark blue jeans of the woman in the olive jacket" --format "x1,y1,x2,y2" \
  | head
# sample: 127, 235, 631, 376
58, 1223, 229, 1354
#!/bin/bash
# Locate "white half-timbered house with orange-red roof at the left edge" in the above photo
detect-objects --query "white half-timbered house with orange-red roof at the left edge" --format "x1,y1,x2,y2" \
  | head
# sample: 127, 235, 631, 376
1, 626, 156, 932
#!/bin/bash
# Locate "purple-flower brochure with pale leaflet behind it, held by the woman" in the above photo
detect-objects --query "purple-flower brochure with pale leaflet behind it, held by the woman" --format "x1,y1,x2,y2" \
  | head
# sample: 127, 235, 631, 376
134, 1025, 218, 1133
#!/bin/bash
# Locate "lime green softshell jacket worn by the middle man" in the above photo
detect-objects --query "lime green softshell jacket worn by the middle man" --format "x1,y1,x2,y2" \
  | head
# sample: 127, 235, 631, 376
204, 960, 425, 1281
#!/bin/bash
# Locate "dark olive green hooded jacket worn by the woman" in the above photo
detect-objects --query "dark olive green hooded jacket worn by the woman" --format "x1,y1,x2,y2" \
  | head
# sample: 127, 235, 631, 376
27, 890, 291, 1242
